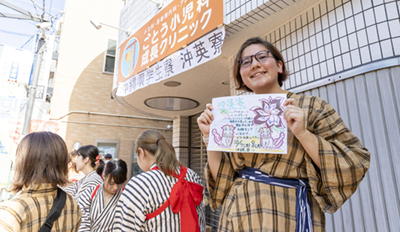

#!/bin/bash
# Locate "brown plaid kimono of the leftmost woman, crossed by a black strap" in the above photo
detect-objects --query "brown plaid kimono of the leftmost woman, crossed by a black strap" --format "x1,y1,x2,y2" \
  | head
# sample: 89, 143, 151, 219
0, 184, 82, 232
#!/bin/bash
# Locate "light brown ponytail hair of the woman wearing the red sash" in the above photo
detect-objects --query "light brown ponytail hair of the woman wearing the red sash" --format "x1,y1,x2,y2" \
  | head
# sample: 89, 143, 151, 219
135, 130, 183, 176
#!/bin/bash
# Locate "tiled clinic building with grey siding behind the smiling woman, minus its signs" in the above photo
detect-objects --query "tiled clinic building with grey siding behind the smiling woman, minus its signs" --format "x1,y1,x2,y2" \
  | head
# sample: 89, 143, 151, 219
113, 0, 400, 232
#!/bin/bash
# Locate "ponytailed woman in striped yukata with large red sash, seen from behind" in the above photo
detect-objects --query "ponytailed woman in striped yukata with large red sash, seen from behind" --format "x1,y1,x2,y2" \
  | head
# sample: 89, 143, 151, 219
114, 130, 206, 232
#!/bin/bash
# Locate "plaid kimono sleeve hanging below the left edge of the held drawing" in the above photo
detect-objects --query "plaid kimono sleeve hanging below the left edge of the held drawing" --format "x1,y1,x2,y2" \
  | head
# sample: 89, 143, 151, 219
204, 152, 235, 211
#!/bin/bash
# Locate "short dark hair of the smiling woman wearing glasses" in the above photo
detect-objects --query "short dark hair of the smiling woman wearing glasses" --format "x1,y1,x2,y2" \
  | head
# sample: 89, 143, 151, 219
233, 37, 289, 92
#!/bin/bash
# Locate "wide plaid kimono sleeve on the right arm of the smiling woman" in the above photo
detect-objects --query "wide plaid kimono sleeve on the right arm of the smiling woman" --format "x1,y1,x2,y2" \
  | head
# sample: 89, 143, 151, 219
306, 98, 370, 213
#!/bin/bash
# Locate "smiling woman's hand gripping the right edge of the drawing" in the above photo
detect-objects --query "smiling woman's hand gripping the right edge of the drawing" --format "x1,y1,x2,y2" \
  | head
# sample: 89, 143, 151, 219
283, 98, 309, 139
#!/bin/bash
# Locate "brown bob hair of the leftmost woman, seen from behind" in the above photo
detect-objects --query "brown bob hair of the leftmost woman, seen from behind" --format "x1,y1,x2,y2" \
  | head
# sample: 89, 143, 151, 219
10, 131, 69, 192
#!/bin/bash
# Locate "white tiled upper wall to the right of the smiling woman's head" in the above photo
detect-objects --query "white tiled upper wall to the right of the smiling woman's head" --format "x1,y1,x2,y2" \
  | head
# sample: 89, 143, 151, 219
253, 0, 400, 88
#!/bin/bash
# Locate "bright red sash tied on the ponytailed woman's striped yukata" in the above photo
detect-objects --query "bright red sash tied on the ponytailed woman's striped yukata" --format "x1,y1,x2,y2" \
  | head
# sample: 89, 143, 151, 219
146, 167, 203, 232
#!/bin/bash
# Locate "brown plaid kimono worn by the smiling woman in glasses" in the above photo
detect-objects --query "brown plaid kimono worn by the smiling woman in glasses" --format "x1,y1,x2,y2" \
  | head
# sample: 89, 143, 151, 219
205, 91, 370, 232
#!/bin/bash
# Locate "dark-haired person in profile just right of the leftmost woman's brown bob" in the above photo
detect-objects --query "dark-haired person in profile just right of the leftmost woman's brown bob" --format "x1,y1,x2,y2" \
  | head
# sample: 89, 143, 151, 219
63, 145, 103, 201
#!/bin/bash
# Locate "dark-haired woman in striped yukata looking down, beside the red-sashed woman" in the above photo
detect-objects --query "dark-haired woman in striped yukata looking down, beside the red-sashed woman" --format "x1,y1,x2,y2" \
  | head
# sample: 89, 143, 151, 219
78, 159, 128, 232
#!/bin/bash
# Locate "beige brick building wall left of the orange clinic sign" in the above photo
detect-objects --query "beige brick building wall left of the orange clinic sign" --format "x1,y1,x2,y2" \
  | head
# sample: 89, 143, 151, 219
50, 0, 172, 176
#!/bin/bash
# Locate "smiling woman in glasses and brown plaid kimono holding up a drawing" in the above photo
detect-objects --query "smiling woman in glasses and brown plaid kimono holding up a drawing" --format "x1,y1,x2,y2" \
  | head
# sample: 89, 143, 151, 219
197, 38, 370, 232
